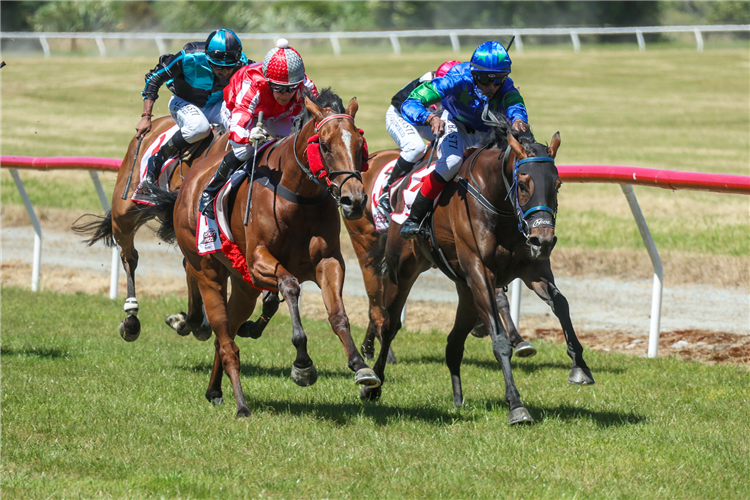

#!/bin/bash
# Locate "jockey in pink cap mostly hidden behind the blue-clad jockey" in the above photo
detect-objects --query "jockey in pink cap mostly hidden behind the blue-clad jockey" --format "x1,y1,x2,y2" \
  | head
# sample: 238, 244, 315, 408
378, 61, 461, 212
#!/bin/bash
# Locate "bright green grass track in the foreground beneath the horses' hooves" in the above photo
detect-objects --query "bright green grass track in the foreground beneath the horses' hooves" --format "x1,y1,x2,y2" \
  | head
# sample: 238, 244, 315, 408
0, 288, 750, 499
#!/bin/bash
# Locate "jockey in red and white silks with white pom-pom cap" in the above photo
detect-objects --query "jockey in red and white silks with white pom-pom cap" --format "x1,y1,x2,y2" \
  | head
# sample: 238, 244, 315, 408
200, 38, 318, 219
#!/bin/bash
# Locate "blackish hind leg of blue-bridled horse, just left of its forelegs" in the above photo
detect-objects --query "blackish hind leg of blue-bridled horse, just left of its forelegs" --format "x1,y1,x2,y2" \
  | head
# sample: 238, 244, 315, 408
445, 285, 478, 408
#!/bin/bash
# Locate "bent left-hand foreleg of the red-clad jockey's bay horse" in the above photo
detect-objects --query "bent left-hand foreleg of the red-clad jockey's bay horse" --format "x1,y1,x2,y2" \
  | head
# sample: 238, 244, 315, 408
250, 246, 318, 387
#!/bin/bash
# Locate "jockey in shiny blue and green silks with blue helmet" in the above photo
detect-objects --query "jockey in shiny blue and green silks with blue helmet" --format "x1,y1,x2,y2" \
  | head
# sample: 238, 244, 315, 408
401, 41, 529, 239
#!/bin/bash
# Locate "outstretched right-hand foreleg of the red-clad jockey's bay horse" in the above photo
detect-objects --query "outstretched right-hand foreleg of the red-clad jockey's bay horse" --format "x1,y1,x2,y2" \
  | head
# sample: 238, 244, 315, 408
315, 255, 380, 387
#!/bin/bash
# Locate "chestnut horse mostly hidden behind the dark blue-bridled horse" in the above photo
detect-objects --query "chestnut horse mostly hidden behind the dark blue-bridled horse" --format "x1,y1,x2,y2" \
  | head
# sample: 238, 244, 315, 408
344, 143, 536, 363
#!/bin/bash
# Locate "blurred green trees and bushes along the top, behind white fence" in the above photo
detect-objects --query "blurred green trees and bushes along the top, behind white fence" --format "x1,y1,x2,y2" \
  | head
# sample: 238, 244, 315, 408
0, 0, 750, 33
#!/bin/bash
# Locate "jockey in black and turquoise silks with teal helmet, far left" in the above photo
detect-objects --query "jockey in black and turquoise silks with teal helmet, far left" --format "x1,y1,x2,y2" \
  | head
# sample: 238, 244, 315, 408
135, 29, 253, 189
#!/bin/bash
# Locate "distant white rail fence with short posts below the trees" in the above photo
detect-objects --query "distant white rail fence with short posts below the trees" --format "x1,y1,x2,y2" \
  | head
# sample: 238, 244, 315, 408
0, 24, 750, 57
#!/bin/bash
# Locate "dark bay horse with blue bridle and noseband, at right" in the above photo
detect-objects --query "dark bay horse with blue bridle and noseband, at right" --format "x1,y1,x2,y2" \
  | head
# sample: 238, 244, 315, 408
360, 119, 594, 424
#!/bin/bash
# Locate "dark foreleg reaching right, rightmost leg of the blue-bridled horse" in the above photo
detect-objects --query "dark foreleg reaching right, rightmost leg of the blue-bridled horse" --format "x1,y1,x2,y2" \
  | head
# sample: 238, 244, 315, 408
531, 278, 594, 385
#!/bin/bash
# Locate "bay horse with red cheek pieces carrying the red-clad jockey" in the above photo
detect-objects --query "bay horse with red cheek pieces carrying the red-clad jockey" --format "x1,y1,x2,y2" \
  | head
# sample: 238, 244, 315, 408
137, 89, 380, 417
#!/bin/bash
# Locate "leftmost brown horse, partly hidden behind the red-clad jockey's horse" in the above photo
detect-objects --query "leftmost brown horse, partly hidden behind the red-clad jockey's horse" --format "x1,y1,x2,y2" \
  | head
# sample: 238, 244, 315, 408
73, 117, 227, 342
